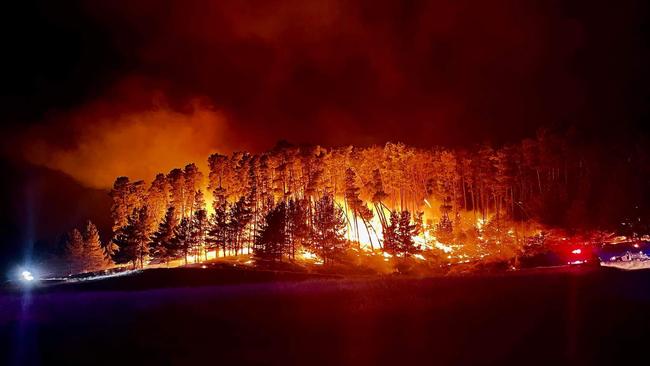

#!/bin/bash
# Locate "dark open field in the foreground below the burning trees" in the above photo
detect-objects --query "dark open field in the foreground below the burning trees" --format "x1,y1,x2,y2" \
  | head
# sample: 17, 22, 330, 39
0, 269, 650, 365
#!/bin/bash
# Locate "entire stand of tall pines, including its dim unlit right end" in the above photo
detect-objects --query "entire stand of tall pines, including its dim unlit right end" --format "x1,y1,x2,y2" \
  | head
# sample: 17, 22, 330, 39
64, 131, 647, 266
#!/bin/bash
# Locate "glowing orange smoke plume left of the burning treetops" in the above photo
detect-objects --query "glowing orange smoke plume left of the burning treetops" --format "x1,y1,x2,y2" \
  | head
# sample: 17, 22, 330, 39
22, 92, 229, 188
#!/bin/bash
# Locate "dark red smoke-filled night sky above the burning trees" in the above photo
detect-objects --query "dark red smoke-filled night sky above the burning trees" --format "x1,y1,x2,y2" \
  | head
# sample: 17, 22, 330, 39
3, 0, 649, 186
